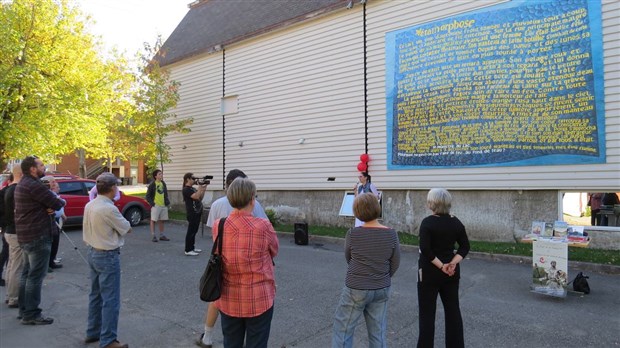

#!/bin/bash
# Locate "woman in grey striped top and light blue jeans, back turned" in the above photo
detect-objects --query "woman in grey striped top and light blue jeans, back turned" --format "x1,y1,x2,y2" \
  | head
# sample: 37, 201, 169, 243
332, 193, 400, 348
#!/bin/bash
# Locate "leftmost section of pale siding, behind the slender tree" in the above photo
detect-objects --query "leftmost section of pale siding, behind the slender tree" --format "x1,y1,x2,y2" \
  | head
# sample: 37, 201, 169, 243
164, 53, 223, 189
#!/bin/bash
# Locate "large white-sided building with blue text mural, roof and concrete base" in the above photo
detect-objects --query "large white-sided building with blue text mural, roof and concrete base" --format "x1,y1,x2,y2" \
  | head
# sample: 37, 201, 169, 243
151, 0, 620, 246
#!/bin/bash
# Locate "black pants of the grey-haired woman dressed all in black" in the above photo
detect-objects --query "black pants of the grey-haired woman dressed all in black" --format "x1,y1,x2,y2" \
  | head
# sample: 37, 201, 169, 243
418, 266, 465, 348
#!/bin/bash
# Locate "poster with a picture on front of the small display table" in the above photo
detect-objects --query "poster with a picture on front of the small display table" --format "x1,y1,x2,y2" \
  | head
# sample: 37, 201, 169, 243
531, 240, 568, 297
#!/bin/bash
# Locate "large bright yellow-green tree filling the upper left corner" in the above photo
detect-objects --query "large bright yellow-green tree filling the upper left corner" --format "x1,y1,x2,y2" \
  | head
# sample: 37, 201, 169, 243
0, 0, 127, 161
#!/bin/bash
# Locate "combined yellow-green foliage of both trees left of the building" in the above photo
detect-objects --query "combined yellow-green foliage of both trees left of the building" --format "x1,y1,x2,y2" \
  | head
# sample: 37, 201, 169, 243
0, 0, 192, 167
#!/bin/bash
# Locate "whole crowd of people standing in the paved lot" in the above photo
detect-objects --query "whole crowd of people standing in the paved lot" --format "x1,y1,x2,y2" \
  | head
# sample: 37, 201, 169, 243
0, 156, 469, 348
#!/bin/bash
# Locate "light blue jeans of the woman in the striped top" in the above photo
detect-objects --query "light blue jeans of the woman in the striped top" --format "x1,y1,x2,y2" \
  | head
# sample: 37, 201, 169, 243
332, 286, 390, 348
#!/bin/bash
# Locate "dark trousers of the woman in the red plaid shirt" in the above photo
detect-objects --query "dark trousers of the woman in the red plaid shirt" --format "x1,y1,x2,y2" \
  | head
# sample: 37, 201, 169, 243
220, 306, 273, 348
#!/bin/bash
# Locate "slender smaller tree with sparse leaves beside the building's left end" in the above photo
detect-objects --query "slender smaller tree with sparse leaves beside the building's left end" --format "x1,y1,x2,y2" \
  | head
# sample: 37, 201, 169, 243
131, 37, 193, 169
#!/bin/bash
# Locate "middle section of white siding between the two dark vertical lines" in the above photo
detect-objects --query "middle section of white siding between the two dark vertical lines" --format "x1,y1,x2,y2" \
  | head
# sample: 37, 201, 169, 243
226, 6, 364, 190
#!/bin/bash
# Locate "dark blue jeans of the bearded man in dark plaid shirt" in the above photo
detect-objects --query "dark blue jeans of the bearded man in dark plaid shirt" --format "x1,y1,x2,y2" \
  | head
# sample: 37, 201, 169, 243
19, 236, 52, 320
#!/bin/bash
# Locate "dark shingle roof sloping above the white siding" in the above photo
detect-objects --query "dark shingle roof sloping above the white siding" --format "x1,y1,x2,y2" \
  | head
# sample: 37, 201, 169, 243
156, 0, 348, 66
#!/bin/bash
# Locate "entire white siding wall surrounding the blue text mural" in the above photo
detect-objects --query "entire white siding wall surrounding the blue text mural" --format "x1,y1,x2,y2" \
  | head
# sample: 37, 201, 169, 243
166, 0, 620, 191
